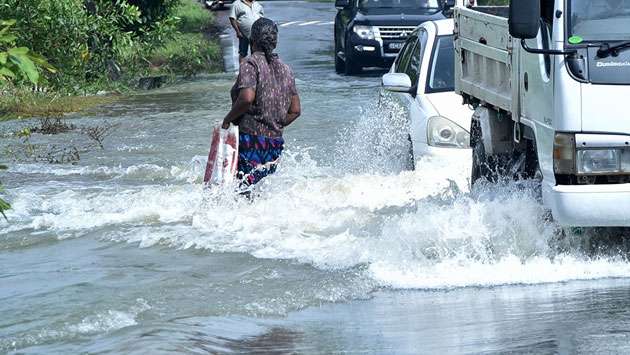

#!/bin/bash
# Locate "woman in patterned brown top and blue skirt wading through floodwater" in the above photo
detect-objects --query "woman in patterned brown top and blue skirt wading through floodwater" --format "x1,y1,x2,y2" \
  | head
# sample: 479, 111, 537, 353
223, 18, 301, 192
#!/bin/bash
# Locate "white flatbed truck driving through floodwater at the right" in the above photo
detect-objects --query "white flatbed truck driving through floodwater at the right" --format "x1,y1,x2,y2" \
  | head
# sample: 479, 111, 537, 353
454, 0, 630, 227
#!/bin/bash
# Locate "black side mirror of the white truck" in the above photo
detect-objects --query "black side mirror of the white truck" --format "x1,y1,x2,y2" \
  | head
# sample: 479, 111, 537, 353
509, 0, 540, 39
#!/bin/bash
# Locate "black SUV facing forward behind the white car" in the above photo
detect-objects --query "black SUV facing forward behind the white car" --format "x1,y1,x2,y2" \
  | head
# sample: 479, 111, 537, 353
335, 0, 454, 75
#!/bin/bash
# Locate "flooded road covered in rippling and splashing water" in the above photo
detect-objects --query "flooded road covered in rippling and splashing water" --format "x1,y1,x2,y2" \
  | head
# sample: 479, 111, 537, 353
0, 2, 630, 354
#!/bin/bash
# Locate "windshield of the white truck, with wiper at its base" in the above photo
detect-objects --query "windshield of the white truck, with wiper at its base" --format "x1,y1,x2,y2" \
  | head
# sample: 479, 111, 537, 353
569, 0, 630, 42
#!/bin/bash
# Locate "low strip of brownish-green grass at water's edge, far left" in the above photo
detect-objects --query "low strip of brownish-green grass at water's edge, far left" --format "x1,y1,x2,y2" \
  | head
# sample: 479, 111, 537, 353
0, 89, 118, 121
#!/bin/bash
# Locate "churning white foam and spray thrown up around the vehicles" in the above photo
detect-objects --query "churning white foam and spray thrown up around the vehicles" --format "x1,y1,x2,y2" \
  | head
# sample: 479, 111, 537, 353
4, 96, 630, 292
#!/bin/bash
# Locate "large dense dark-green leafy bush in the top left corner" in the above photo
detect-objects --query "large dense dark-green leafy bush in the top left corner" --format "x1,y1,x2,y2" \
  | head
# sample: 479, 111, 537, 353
0, 0, 179, 92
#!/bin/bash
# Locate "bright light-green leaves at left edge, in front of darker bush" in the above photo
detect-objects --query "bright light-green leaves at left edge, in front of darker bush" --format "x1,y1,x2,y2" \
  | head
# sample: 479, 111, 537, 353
0, 20, 56, 85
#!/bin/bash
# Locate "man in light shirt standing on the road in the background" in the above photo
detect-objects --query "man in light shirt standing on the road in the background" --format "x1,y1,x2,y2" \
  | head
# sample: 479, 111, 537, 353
230, 0, 265, 61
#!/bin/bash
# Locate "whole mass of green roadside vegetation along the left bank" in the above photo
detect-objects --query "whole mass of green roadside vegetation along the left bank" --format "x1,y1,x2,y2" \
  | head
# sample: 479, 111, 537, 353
0, 0, 221, 103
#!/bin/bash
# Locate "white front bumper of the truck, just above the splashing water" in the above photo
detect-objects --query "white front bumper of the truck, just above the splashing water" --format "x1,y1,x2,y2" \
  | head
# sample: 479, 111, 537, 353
543, 184, 630, 227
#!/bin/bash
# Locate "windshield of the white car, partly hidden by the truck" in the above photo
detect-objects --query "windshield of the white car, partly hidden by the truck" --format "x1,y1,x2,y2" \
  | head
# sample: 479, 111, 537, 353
426, 36, 455, 94
